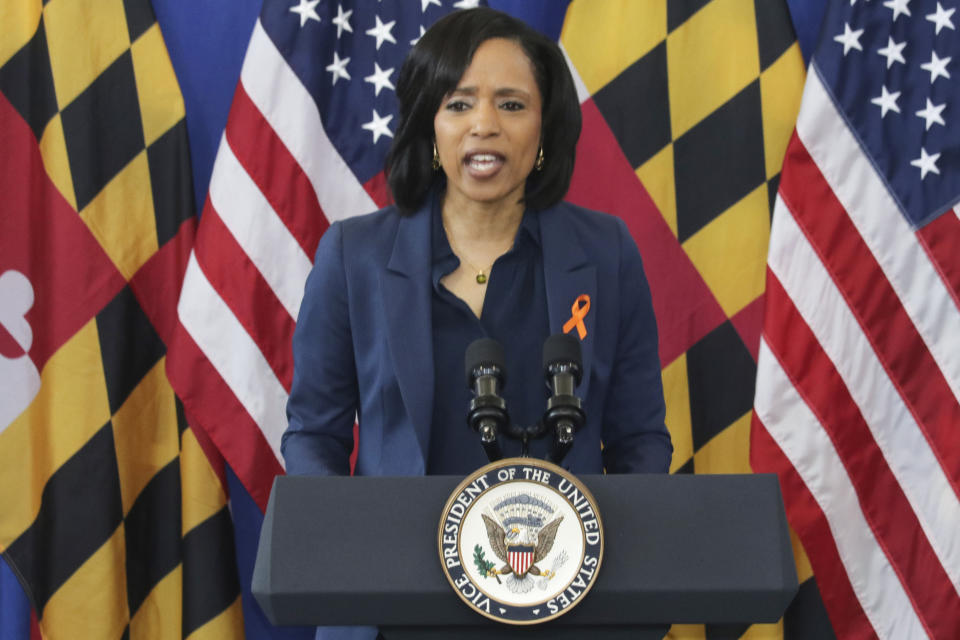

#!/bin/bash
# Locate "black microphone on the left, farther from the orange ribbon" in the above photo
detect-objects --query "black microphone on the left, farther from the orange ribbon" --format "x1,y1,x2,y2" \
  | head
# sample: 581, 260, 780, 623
464, 338, 510, 462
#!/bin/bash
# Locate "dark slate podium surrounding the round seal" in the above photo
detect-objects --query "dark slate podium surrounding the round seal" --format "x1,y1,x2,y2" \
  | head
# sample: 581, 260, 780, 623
253, 474, 797, 640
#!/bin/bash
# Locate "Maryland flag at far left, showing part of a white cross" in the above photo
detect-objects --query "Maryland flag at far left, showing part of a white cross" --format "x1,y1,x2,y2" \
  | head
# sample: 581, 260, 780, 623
0, 0, 242, 638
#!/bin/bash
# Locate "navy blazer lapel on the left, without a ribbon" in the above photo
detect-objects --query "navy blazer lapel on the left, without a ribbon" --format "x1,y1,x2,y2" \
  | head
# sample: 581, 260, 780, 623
380, 202, 434, 473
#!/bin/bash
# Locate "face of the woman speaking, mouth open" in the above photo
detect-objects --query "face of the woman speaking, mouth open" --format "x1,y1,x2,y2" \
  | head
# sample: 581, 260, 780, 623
433, 38, 541, 211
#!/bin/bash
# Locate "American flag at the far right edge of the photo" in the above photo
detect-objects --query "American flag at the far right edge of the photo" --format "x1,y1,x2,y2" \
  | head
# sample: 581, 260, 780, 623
751, 0, 960, 639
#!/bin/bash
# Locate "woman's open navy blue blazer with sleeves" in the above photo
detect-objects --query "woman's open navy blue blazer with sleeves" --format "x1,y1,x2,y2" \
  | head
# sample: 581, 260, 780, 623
281, 198, 672, 476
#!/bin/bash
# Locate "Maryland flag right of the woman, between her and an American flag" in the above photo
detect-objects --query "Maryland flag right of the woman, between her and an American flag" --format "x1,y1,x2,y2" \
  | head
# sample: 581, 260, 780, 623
561, 0, 833, 640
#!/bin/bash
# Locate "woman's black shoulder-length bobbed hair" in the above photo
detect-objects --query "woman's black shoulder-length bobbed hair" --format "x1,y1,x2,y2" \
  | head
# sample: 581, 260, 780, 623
386, 7, 581, 213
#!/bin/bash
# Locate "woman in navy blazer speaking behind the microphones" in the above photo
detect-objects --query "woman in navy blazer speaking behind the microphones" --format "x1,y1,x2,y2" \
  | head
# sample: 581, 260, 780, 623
282, 9, 672, 475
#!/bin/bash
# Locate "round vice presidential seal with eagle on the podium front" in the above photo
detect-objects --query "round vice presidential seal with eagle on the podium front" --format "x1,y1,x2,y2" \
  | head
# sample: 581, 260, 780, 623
437, 458, 603, 624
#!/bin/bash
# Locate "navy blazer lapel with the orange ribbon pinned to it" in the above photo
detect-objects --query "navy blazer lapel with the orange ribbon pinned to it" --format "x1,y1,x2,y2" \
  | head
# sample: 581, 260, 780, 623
540, 208, 600, 399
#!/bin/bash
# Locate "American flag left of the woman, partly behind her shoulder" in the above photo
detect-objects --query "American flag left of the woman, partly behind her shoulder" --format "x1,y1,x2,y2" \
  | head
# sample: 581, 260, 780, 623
168, 0, 478, 509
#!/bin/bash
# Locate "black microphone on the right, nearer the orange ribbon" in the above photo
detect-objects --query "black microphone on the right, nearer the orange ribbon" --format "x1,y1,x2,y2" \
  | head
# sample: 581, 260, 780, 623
543, 333, 587, 464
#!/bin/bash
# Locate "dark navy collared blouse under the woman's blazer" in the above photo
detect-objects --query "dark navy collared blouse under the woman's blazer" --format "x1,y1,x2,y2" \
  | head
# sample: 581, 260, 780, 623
427, 206, 550, 475
